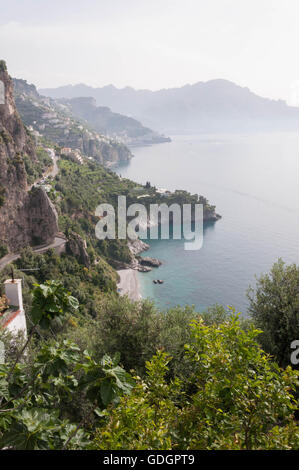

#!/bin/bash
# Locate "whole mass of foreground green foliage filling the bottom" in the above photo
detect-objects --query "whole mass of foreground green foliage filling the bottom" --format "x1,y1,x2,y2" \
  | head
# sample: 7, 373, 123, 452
0, 281, 299, 450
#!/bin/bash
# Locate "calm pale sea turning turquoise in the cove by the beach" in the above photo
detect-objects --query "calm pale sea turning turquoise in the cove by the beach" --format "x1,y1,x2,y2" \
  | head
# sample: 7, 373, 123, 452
116, 133, 299, 314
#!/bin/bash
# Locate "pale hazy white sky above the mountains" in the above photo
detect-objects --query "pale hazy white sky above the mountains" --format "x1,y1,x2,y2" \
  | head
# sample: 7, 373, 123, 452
0, 0, 299, 104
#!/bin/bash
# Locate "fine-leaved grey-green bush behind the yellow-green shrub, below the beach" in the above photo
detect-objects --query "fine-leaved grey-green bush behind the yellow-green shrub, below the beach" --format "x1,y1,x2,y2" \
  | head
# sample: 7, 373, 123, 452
63, 294, 198, 375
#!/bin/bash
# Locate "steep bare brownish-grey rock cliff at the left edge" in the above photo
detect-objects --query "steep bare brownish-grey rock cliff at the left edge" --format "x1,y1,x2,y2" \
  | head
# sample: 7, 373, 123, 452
0, 61, 58, 252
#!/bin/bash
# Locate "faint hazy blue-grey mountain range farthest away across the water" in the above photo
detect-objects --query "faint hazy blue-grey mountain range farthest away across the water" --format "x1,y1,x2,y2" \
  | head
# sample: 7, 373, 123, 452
40, 79, 299, 134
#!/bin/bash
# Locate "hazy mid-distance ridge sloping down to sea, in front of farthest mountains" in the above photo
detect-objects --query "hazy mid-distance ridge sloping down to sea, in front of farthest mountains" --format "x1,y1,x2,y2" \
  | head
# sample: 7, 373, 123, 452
14, 78, 170, 149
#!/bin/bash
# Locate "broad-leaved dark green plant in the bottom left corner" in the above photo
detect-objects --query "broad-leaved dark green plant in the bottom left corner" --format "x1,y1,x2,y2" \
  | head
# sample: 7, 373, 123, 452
0, 281, 134, 450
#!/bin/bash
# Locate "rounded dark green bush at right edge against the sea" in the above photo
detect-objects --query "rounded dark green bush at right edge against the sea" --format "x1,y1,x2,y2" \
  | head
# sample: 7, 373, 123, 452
248, 260, 299, 366
